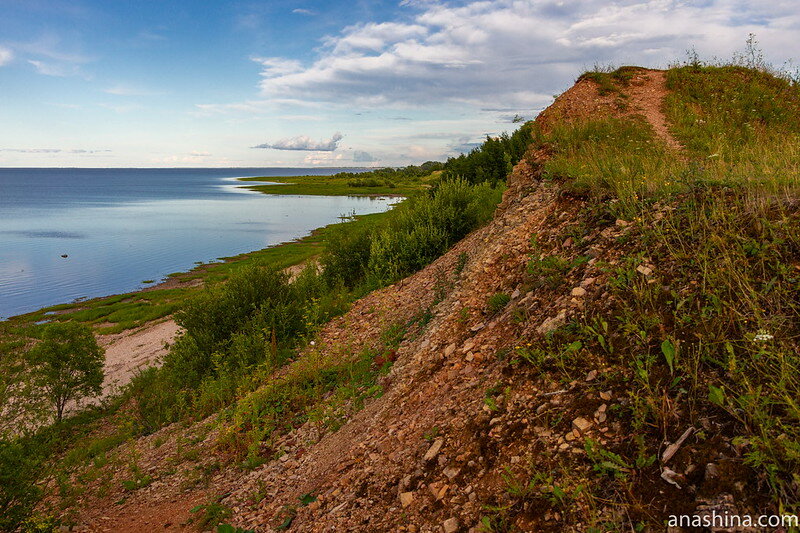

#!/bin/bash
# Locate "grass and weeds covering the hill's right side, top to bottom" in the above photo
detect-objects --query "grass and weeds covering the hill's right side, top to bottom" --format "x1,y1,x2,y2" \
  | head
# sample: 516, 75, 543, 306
501, 66, 800, 528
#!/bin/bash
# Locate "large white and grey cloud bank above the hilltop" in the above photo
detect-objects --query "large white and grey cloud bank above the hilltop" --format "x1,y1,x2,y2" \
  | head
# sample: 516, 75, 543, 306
252, 0, 800, 113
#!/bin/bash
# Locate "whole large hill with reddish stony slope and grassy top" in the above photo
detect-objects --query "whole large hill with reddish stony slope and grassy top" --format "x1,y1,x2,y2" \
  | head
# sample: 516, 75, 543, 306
6, 61, 800, 533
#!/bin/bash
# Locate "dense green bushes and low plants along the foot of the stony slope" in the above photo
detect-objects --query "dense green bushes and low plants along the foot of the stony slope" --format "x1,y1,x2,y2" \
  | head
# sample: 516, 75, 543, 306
0, 141, 502, 528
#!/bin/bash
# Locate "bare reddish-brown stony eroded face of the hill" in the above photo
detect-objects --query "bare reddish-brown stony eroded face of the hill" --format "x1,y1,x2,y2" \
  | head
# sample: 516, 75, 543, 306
56, 70, 768, 533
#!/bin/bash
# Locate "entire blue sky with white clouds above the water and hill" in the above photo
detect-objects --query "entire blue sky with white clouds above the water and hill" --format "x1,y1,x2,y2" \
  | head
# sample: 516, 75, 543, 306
0, 0, 800, 167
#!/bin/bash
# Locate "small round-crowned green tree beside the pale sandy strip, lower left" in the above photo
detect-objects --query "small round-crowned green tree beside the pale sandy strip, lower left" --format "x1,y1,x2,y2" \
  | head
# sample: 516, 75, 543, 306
28, 322, 105, 422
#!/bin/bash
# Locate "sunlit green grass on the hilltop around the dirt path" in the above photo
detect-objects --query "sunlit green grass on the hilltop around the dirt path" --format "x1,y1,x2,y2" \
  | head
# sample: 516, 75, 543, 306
534, 66, 800, 219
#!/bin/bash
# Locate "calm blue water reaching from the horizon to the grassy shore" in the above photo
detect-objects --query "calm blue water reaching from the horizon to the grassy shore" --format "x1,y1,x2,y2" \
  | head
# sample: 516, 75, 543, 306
0, 168, 390, 318
